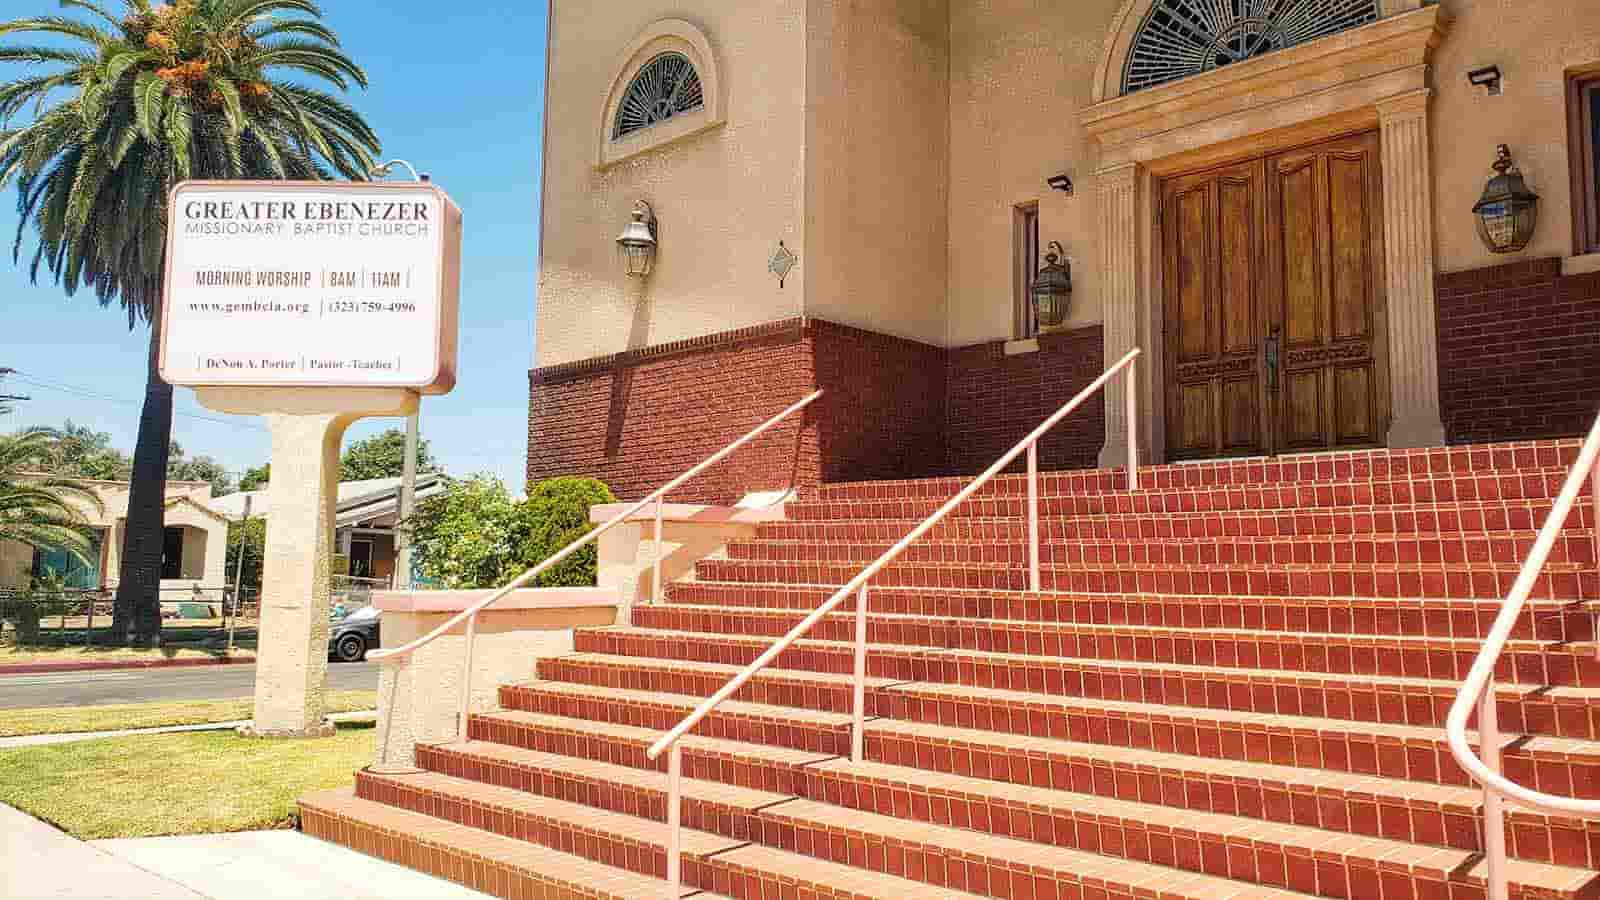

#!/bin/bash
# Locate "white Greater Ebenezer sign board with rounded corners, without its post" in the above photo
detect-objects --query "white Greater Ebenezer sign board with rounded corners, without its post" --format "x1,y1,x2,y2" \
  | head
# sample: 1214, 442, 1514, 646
160, 181, 461, 394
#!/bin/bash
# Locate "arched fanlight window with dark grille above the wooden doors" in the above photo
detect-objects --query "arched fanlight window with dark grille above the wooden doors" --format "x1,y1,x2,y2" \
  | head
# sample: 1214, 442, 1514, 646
1122, 0, 1378, 93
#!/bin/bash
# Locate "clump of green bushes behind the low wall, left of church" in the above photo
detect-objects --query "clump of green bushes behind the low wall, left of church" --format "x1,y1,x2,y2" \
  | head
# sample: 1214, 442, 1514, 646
410, 476, 616, 588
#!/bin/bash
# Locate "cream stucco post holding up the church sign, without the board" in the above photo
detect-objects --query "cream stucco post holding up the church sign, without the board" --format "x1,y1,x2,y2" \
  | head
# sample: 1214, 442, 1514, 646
195, 388, 418, 737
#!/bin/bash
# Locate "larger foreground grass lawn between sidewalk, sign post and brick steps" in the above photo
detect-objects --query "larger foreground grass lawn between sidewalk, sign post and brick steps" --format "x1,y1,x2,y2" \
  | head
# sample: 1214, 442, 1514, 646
0, 725, 376, 841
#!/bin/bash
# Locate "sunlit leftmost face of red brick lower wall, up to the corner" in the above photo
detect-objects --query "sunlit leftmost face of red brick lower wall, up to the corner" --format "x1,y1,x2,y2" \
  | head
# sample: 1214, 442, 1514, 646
528, 319, 819, 503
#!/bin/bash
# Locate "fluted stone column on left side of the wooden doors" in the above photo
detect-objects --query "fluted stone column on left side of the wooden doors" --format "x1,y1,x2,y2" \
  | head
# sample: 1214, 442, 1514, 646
1094, 162, 1149, 469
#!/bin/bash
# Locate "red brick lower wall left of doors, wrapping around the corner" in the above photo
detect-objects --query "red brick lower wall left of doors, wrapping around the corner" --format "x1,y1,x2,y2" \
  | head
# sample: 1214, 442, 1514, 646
528, 319, 1104, 503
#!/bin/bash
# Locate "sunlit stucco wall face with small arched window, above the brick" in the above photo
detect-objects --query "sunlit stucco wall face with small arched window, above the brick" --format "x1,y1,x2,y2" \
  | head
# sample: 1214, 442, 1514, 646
536, 0, 808, 367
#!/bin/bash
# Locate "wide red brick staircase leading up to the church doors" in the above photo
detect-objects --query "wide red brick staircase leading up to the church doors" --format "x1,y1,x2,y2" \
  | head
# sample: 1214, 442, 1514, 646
301, 442, 1600, 900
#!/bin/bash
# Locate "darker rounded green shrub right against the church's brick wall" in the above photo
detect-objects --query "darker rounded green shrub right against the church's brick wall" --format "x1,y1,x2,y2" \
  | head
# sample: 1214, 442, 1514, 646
510, 477, 616, 588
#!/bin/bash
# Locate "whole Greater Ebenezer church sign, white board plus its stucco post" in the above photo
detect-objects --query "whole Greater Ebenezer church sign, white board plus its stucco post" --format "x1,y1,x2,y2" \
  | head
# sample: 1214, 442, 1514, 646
160, 181, 461, 737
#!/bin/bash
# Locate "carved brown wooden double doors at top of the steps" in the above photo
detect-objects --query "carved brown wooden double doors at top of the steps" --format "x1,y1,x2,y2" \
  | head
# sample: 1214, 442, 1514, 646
1160, 131, 1389, 460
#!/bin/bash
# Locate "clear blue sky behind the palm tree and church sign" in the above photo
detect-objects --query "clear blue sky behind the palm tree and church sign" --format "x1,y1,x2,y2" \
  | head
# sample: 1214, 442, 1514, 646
0, 0, 546, 492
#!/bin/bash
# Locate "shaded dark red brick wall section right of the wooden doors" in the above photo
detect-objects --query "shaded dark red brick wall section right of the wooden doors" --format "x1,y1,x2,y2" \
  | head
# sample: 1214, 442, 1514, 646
1437, 259, 1600, 444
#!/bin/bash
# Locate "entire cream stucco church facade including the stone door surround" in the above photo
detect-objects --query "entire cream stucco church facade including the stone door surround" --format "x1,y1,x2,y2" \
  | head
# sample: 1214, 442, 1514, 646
534, 0, 1600, 461
